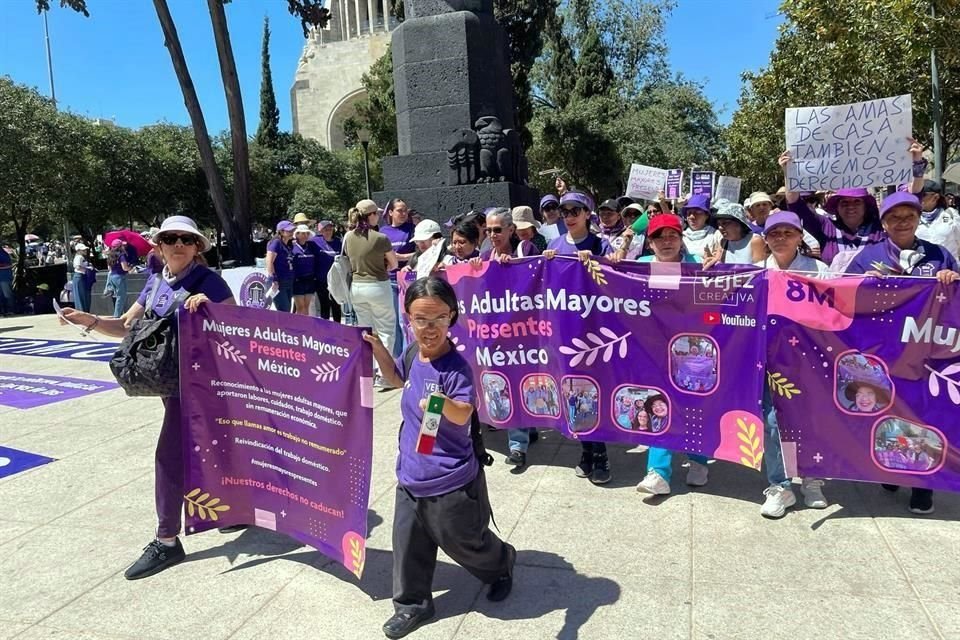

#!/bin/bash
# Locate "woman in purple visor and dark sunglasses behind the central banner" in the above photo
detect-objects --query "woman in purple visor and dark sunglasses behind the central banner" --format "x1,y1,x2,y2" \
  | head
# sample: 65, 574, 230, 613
543, 191, 613, 484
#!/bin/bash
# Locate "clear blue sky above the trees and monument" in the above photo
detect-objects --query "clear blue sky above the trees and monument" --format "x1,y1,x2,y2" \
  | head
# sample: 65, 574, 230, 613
0, 0, 780, 133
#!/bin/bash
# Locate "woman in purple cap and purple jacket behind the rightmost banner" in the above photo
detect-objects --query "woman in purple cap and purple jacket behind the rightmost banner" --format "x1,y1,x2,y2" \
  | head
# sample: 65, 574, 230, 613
847, 191, 960, 515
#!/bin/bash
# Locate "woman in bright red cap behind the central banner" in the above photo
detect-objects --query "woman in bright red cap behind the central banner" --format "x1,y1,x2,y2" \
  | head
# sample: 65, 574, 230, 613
637, 215, 709, 496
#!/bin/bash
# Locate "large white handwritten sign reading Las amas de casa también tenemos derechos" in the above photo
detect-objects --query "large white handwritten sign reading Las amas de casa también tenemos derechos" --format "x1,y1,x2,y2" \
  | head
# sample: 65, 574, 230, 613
785, 95, 913, 191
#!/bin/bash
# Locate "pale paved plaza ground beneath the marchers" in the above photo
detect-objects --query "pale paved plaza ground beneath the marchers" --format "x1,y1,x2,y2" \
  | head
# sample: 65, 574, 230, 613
0, 317, 960, 640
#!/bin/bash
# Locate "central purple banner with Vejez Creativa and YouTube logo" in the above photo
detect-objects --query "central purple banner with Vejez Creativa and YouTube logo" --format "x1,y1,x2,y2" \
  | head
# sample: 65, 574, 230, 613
436, 257, 766, 468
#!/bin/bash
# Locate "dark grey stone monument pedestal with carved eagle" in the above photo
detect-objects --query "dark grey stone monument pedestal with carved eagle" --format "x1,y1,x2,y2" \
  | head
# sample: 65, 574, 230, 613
374, 0, 538, 221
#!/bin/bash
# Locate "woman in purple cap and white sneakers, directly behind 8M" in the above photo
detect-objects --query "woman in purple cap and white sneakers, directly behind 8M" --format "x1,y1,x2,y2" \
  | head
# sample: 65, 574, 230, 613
757, 211, 830, 518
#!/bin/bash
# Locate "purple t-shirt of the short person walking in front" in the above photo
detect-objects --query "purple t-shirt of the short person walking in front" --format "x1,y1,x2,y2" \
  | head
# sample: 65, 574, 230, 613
396, 349, 479, 498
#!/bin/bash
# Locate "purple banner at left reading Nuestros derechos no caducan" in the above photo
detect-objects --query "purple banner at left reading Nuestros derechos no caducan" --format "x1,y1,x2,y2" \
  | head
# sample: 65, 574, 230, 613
179, 304, 373, 577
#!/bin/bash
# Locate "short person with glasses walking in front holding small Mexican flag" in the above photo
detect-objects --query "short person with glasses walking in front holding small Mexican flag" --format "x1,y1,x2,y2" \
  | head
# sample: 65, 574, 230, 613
364, 276, 517, 638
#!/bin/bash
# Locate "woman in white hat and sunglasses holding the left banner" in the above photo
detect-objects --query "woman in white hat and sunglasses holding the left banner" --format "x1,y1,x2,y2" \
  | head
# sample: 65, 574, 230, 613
61, 216, 234, 580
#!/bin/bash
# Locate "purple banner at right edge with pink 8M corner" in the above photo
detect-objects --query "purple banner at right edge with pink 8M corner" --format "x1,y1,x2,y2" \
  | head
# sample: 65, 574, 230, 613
767, 272, 960, 491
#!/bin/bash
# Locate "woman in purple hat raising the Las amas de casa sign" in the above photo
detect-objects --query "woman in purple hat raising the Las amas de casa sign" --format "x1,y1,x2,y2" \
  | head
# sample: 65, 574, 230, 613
778, 140, 927, 272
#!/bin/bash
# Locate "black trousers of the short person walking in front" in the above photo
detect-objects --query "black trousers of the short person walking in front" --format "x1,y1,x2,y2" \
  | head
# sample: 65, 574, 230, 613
393, 471, 517, 614
